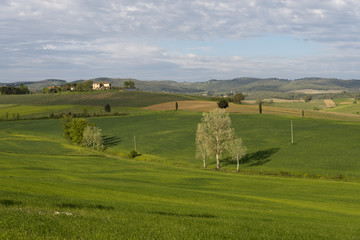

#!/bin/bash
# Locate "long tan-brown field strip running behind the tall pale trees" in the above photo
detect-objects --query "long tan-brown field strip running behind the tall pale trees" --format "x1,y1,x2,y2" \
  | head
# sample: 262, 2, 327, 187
144, 101, 360, 122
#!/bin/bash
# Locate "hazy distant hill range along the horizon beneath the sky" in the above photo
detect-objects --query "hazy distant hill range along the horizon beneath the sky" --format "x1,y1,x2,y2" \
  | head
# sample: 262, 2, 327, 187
0, 77, 360, 94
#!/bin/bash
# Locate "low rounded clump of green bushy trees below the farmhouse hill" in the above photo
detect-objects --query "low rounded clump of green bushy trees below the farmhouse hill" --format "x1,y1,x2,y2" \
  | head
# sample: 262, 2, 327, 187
62, 116, 104, 150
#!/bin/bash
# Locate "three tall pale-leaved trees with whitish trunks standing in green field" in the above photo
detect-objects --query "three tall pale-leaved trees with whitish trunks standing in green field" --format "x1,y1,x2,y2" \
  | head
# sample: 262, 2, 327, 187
195, 108, 246, 171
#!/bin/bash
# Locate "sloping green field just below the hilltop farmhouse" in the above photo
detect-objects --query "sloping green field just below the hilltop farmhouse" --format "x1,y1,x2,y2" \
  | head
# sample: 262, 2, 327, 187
0, 91, 199, 120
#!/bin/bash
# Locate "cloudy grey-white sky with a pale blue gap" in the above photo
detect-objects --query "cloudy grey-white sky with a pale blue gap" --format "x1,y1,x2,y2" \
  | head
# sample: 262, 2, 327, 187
0, 0, 360, 83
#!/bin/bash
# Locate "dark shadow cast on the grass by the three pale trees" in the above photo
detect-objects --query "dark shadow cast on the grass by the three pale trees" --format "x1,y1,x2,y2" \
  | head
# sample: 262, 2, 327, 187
222, 148, 280, 166
